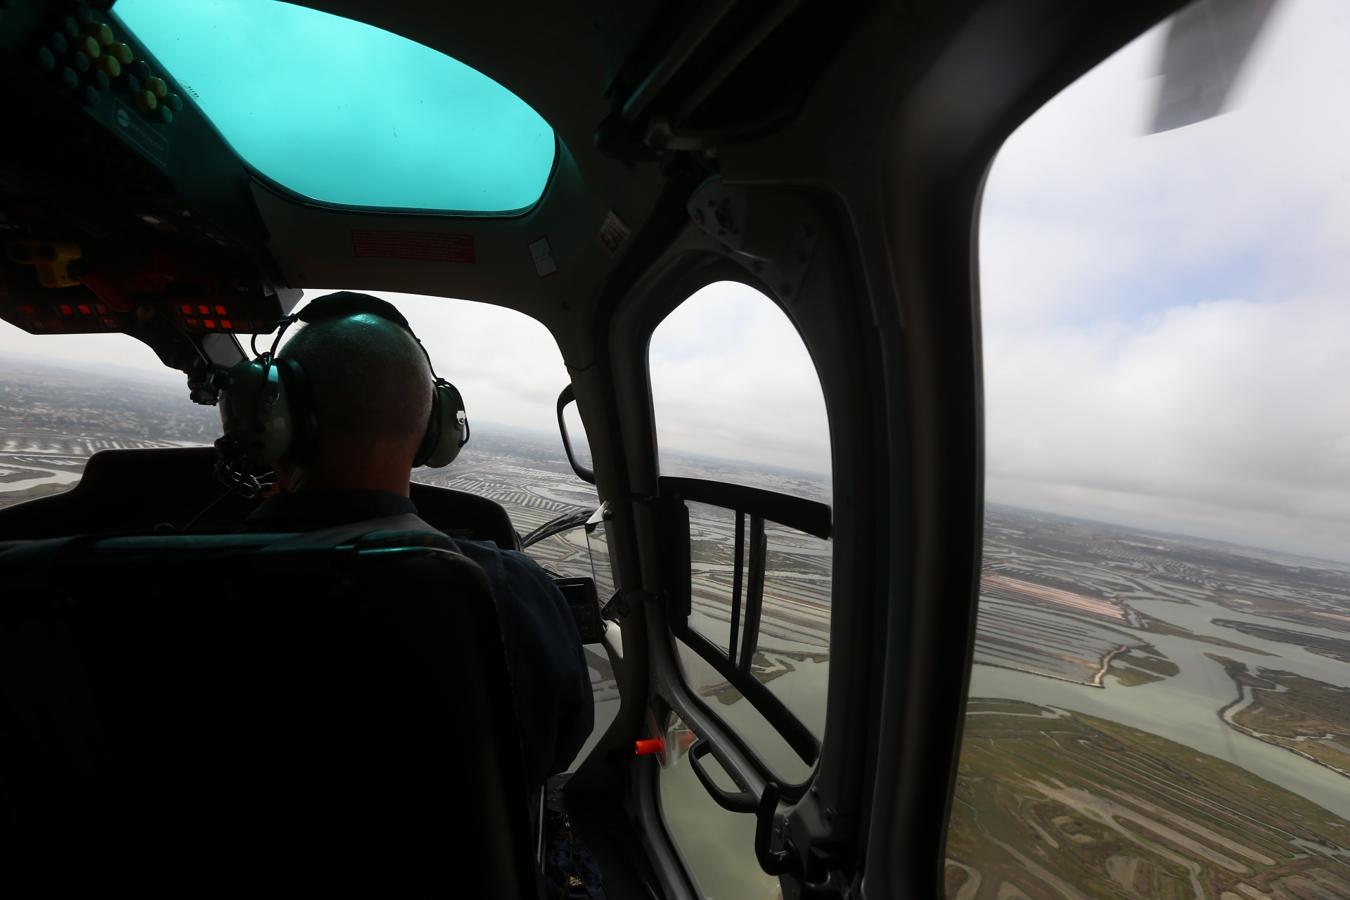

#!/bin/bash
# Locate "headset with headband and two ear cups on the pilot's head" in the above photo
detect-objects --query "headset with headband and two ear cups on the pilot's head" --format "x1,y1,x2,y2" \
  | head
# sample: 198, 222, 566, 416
216, 290, 468, 480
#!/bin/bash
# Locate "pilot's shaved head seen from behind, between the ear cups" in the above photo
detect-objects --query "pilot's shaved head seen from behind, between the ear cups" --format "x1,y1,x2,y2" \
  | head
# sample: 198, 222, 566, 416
279, 310, 432, 479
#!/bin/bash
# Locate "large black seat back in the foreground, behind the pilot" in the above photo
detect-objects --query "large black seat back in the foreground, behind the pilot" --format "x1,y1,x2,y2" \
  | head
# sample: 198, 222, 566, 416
0, 534, 536, 897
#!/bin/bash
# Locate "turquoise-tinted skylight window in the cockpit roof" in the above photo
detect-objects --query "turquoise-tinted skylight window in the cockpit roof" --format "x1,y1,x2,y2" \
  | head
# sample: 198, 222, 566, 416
116, 0, 555, 213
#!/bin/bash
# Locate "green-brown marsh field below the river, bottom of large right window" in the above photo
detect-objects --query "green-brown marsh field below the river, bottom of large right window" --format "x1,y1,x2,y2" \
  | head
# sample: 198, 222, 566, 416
946, 699, 1350, 900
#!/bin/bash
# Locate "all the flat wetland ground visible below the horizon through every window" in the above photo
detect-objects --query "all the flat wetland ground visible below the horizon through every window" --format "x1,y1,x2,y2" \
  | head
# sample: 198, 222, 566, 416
0, 364, 1350, 900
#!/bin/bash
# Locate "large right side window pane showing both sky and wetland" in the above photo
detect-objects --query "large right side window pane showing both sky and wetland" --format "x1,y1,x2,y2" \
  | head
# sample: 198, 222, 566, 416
946, 0, 1350, 899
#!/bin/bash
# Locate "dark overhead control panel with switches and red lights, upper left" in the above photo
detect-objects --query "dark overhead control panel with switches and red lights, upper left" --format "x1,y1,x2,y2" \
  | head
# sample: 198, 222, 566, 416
0, 0, 298, 383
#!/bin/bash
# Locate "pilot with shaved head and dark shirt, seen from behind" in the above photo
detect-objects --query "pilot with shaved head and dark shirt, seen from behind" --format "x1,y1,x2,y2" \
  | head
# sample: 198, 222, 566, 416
236, 291, 594, 784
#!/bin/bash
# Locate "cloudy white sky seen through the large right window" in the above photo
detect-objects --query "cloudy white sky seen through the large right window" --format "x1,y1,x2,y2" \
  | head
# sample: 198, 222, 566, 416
980, 0, 1350, 559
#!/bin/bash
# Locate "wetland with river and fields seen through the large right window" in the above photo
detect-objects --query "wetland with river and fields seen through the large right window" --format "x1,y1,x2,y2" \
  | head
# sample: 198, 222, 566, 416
946, 505, 1350, 900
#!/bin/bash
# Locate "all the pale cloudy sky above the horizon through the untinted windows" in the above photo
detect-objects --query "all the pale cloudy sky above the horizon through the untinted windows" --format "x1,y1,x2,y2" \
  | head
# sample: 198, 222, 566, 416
0, 0, 1350, 560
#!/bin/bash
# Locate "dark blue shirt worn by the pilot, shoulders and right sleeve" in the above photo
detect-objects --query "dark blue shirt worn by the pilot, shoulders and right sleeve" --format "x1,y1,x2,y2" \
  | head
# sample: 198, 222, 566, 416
244, 490, 595, 784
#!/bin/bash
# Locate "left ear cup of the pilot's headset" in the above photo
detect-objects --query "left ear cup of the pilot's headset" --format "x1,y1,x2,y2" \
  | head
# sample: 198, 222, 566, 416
219, 359, 292, 466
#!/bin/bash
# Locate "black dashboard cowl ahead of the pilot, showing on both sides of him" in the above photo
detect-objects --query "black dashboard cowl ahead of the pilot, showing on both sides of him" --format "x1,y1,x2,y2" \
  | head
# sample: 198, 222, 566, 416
0, 447, 520, 551
